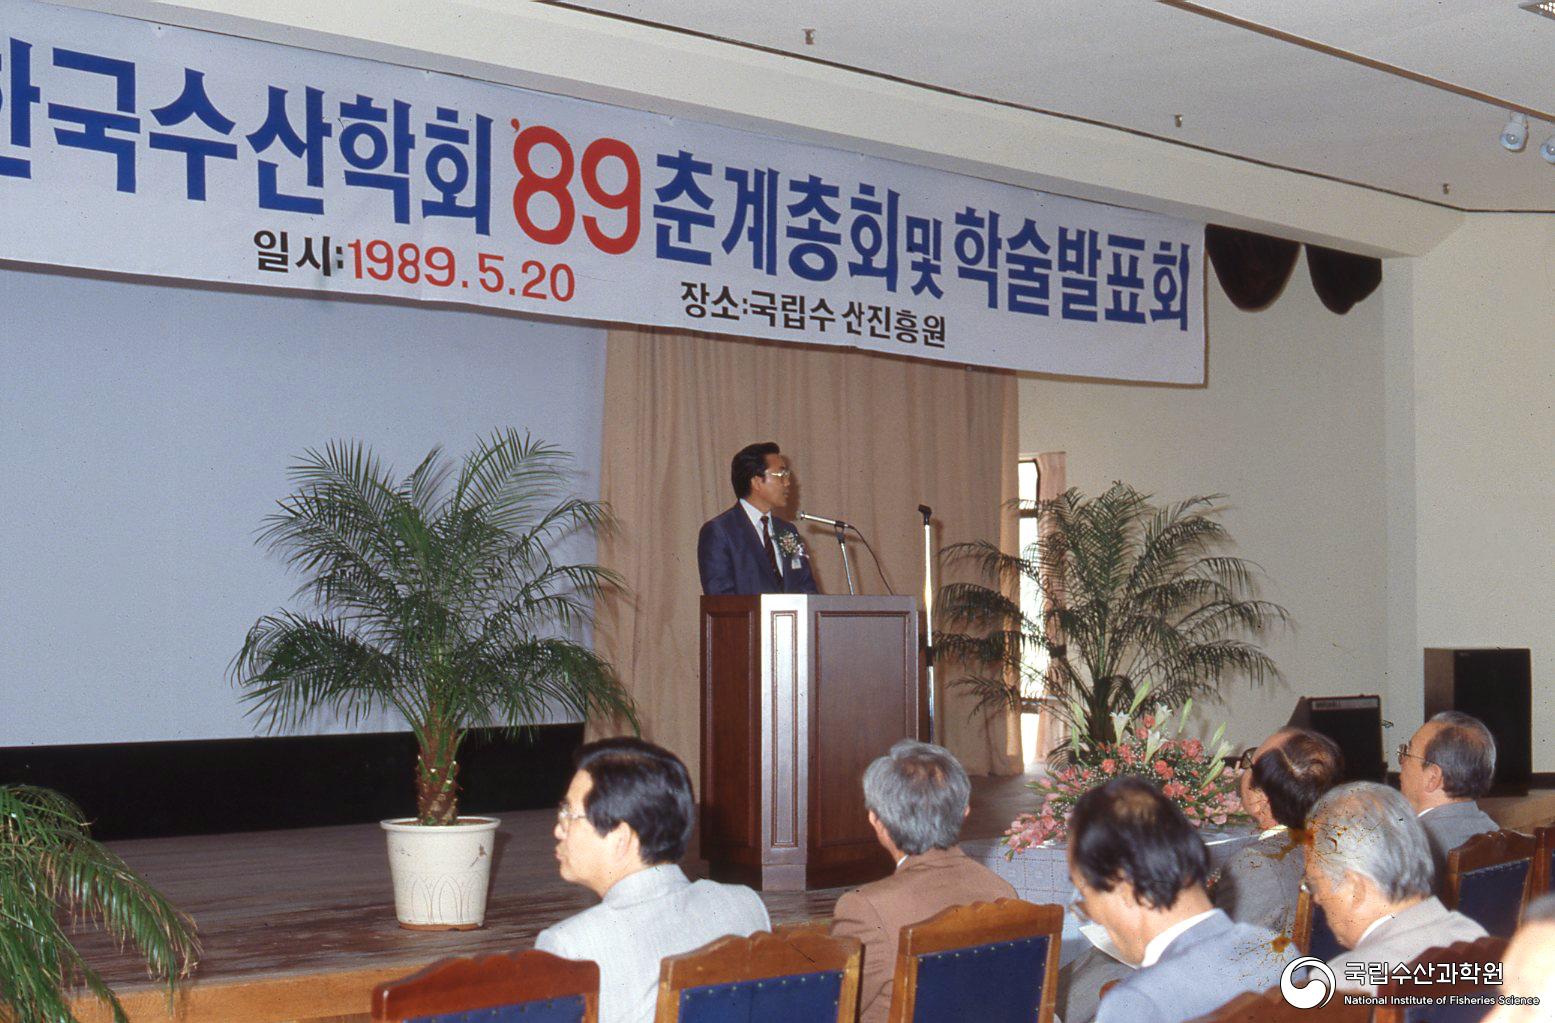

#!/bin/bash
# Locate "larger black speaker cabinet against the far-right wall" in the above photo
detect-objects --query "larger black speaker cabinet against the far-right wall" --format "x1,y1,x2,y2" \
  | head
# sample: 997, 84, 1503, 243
1426, 647, 1533, 796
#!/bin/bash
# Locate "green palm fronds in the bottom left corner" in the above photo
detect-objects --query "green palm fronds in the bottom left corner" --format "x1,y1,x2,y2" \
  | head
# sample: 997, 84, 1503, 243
0, 785, 199, 1023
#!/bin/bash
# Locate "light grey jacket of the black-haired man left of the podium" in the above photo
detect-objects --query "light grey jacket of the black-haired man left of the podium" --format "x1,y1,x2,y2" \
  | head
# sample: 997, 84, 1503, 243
535, 863, 771, 1023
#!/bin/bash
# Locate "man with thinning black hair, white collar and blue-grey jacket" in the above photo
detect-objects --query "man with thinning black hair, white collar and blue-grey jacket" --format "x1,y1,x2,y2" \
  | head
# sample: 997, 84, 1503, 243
1068, 777, 1294, 1023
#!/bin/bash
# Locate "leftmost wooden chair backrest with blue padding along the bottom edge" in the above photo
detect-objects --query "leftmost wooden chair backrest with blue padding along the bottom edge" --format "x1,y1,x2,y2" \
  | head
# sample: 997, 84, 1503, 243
373, 950, 599, 1023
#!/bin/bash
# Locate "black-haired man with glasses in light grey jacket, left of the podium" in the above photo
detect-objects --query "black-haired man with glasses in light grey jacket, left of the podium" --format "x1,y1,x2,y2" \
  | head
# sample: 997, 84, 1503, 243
535, 738, 770, 1023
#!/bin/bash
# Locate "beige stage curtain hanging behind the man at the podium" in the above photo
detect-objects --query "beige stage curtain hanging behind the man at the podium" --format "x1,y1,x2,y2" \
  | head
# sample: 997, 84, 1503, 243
597, 328, 1022, 777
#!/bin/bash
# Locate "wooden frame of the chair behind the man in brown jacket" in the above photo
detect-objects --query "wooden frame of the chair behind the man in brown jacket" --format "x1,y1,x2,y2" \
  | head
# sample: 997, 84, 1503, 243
888, 899, 1064, 1023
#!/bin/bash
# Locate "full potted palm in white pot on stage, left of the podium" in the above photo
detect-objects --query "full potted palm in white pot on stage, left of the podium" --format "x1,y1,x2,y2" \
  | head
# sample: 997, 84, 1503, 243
232, 431, 636, 930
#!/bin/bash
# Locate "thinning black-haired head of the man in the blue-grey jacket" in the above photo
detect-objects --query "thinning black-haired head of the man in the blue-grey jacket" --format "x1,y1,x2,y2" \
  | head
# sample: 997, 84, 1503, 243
1068, 777, 1210, 910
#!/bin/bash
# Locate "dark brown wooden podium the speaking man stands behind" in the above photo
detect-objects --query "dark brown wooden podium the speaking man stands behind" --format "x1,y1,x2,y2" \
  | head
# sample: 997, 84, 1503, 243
701, 594, 921, 891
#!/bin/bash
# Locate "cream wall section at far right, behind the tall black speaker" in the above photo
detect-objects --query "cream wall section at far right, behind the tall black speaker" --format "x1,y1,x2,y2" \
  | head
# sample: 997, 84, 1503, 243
1387, 213, 1555, 771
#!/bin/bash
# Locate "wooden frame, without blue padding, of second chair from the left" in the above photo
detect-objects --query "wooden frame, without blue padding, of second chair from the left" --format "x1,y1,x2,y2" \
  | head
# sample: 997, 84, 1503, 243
653, 922, 863, 1023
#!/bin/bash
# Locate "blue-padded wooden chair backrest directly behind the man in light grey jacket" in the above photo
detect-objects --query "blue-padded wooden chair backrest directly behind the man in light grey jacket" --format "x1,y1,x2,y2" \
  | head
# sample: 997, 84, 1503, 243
653, 925, 861, 1023
